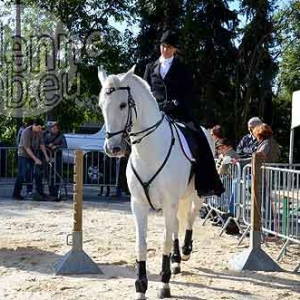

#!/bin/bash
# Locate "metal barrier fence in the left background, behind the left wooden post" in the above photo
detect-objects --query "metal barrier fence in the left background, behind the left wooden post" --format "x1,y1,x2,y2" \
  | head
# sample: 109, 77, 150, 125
0, 147, 121, 193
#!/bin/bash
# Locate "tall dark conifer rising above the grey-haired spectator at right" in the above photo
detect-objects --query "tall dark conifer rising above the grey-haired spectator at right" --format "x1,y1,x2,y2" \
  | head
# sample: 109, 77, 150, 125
238, 0, 278, 124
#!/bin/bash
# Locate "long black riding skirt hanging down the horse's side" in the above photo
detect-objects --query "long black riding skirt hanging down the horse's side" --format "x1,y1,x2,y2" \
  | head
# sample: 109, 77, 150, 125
195, 128, 225, 197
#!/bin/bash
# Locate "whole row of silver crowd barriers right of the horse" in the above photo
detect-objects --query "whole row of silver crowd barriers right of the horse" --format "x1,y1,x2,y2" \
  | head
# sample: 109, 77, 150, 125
203, 160, 300, 266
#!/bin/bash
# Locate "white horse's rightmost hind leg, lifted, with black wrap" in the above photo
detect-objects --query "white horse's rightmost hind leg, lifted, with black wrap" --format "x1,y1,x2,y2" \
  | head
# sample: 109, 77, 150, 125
182, 193, 203, 261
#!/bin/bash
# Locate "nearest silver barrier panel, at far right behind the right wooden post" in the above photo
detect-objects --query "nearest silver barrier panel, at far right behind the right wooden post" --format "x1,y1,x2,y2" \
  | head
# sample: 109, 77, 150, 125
239, 164, 300, 260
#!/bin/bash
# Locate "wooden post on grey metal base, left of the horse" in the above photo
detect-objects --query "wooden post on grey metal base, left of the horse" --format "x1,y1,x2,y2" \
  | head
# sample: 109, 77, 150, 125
56, 150, 102, 274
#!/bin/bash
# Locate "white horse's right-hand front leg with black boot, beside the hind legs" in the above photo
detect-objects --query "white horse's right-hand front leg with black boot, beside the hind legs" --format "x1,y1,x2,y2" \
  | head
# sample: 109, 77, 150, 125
159, 205, 178, 299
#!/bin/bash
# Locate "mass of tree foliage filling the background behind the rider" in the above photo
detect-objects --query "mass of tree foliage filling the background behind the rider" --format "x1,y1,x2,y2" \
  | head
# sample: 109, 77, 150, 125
0, 0, 300, 160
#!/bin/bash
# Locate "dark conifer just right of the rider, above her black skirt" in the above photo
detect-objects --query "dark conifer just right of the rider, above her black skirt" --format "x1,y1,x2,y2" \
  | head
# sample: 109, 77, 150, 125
182, 0, 238, 134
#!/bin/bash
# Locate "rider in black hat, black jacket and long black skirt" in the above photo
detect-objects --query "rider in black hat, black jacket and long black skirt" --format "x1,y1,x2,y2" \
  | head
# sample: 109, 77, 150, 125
144, 30, 224, 197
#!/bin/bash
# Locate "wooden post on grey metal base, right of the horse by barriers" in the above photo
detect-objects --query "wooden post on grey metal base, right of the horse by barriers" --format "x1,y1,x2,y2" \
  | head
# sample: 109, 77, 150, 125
229, 153, 282, 272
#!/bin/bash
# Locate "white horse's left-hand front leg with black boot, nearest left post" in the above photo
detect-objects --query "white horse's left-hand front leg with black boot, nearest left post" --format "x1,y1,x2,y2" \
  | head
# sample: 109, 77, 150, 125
131, 198, 149, 300
